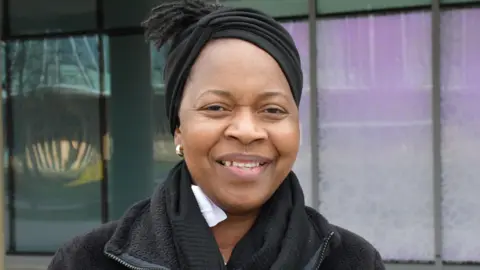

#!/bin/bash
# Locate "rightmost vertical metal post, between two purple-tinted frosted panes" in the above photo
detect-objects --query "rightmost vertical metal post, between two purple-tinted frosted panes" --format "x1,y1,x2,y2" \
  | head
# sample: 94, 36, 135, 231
431, 0, 443, 269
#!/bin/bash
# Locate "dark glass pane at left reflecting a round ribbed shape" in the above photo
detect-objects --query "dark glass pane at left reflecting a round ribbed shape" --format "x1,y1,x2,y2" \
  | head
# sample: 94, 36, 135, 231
7, 36, 103, 252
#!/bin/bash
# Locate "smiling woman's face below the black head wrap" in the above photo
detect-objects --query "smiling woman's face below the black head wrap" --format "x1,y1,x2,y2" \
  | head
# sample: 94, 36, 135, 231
175, 39, 300, 214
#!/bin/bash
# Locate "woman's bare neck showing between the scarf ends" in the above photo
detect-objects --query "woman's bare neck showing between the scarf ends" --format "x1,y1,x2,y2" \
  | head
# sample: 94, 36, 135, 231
212, 210, 260, 262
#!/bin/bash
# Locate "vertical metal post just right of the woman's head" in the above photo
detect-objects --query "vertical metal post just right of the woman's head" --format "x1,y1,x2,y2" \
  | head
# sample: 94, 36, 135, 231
308, 0, 320, 209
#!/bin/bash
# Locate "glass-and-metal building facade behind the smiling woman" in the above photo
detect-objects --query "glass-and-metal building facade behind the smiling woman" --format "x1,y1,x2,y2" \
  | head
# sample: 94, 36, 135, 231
1, 0, 480, 269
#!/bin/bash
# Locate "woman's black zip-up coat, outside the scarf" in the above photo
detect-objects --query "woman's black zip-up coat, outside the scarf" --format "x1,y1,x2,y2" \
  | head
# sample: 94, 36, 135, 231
48, 195, 385, 270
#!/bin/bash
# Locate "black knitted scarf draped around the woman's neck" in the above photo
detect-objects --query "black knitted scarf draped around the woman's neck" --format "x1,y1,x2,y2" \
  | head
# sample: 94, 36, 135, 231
160, 162, 319, 270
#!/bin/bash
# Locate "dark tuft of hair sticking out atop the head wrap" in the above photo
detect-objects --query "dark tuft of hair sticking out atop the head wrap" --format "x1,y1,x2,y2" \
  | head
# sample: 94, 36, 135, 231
142, 0, 222, 49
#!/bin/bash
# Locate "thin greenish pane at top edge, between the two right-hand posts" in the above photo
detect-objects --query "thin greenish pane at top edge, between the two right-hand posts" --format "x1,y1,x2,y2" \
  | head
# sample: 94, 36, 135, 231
317, 0, 431, 14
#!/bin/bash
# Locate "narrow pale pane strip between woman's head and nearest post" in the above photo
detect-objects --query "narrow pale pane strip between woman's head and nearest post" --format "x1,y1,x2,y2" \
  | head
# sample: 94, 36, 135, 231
283, 21, 314, 206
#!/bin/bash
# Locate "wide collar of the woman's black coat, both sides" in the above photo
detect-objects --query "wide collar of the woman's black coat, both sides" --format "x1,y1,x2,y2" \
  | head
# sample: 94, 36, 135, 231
104, 186, 341, 270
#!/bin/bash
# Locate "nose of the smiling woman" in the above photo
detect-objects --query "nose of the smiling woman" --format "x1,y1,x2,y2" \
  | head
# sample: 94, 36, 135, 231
225, 108, 268, 145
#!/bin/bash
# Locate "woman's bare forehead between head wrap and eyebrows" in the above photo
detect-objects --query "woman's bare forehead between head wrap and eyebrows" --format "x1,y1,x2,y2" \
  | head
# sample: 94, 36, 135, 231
185, 39, 293, 98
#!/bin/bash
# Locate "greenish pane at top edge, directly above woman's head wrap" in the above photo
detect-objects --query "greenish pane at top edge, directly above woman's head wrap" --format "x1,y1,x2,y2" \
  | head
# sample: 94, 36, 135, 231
219, 0, 308, 17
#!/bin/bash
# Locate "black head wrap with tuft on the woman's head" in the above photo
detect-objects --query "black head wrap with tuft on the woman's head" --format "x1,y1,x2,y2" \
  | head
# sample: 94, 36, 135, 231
144, 0, 303, 134
